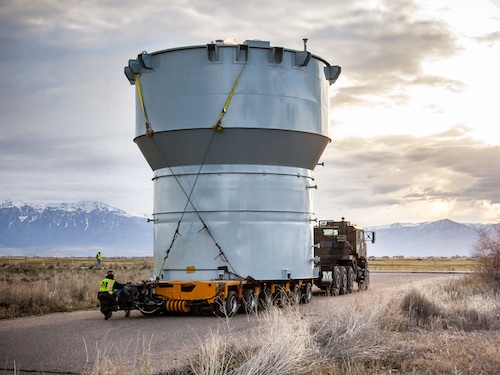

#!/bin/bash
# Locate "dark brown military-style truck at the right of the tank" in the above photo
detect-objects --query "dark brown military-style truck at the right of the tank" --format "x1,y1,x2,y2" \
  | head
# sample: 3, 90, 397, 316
314, 218, 375, 296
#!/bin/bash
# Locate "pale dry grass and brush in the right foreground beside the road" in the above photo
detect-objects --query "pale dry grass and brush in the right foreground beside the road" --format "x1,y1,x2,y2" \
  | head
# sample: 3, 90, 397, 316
163, 276, 500, 375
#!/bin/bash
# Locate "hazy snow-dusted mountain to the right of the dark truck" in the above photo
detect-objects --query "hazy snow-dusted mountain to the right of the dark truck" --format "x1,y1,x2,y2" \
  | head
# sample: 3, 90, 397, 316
366, 219, 500, 257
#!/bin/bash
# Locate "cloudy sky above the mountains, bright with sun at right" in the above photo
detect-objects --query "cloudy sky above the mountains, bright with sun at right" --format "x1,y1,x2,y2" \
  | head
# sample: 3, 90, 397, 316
0, 0, 500, 226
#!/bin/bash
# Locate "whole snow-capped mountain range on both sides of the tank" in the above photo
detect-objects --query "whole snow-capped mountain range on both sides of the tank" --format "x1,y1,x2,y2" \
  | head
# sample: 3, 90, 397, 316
0, 201, 500, 257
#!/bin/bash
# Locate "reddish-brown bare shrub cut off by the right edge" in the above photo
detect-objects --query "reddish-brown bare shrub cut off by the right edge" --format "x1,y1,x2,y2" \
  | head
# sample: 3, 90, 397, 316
472, 227, 500, 290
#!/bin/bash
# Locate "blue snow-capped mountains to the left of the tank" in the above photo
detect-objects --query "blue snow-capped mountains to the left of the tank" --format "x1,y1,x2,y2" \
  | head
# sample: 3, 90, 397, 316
0, 201, 153, 256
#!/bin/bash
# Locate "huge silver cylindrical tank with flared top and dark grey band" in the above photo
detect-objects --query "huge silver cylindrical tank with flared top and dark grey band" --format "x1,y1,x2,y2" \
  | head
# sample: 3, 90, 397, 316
125, 41, 340, 280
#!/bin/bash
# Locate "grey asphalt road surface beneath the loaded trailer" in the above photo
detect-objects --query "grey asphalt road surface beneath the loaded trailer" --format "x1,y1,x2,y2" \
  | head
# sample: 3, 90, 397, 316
0, 272, 460, 374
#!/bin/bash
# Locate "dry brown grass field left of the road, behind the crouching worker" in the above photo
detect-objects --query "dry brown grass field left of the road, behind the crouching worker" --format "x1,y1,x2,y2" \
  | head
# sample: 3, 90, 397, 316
0, 258, 151, 319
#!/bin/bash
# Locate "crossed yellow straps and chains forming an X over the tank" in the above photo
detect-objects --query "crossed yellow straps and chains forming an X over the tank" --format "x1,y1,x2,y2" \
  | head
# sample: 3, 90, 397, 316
156, 62, 247, 278
